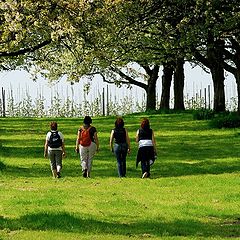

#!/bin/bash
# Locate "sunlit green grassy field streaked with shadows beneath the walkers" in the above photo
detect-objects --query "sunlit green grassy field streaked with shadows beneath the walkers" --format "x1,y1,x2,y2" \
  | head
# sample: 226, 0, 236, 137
0, 114, 240, 240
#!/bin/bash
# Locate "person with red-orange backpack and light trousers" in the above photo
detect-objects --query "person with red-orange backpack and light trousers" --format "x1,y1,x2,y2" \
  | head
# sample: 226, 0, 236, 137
75, 116, 99, 178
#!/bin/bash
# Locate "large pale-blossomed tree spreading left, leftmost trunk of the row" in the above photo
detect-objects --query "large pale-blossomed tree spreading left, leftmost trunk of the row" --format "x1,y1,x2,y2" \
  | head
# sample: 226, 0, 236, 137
0, 0, 189, 110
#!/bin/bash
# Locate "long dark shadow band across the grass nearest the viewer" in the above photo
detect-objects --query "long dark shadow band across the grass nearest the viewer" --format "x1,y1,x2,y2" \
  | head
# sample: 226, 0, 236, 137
0, 212, 240, 237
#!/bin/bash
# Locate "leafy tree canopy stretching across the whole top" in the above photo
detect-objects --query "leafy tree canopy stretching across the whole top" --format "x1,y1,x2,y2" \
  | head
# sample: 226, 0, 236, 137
0, 0, 240, 110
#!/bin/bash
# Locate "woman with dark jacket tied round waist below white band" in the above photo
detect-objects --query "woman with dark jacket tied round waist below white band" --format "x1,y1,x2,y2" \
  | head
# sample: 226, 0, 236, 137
136, 118, 157, 178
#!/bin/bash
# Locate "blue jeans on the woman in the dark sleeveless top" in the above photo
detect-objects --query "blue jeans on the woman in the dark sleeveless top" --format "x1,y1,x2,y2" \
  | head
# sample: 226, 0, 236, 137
114, 143, 128, 177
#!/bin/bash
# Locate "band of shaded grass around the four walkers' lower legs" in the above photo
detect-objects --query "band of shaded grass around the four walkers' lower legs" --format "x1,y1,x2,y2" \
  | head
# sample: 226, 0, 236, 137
0, 159, 240, 179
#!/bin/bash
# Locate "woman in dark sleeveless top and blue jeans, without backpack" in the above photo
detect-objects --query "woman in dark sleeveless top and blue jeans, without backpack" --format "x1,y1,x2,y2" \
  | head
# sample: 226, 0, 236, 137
110, 117, 130, 177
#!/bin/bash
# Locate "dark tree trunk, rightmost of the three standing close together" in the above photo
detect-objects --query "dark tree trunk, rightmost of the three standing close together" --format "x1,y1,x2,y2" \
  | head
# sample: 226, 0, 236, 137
174, 58, 185, 110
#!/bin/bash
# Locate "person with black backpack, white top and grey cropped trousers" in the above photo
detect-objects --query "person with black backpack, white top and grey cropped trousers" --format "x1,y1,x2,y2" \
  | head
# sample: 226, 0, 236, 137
44, 122, 66, 178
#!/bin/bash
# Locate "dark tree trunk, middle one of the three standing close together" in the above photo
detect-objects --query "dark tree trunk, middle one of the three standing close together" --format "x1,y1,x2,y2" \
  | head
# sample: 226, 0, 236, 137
160, 63, 173, 110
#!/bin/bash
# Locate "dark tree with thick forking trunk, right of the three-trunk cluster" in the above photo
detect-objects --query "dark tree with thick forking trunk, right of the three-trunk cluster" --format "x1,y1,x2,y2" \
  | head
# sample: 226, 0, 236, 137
185, 0, 240, 112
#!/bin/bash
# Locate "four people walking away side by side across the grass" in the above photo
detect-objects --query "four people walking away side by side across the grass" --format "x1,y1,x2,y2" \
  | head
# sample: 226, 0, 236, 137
44, 116, 157, 178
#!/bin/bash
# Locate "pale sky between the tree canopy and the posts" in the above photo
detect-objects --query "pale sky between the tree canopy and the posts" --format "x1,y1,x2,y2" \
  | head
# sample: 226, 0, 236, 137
0, 63, 237, 109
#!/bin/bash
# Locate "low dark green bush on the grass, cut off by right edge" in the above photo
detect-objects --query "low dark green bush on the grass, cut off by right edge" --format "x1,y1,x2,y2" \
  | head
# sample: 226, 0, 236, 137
209, 113, 240, 128
